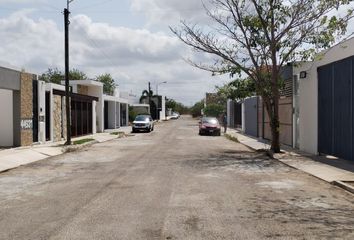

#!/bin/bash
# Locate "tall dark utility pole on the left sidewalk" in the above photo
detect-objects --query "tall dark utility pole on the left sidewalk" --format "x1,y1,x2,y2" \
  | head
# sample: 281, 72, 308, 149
64, 0, 73, 145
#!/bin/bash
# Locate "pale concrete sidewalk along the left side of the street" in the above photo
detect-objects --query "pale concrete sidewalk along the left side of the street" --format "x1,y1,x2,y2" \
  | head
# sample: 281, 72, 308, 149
0, 127, 131, 172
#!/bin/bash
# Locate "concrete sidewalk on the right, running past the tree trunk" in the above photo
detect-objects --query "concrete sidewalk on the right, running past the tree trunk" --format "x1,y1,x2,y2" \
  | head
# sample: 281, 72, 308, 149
226, 129, 354, 193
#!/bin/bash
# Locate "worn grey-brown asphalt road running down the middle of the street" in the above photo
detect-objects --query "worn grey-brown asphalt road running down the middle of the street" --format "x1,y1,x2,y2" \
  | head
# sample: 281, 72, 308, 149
0, 117, 354, 240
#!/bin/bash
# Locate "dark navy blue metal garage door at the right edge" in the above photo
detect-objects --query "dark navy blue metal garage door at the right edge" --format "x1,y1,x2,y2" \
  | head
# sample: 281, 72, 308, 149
317, 57, 354, 160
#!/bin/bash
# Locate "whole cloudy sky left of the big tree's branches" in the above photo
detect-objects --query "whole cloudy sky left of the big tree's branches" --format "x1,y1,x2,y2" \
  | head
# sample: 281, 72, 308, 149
0, 0, 230, 106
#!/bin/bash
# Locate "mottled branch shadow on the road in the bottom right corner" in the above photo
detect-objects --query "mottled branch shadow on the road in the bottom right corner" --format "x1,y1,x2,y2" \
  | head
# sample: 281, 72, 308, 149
242, 195, 354, 239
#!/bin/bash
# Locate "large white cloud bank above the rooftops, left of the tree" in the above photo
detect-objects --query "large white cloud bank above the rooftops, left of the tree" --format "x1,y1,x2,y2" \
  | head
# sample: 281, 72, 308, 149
0, 11, 227, 105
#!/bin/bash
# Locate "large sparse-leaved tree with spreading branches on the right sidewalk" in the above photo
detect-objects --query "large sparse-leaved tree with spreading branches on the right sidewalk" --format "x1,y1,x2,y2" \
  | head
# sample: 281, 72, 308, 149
171, 0, 353, 152
